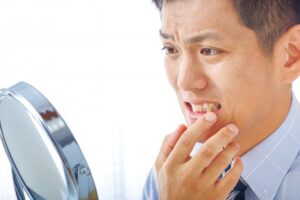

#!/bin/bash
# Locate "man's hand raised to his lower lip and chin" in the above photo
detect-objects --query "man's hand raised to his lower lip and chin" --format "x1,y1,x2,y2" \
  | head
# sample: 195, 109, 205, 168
155, 113, 243, 200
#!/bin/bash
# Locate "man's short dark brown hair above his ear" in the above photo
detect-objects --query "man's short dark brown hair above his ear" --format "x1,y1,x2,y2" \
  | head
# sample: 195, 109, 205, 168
153, 0, 300, 53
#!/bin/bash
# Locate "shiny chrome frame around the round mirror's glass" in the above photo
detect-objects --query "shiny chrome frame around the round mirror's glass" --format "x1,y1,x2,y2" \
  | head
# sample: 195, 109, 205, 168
0, 82, 98, 200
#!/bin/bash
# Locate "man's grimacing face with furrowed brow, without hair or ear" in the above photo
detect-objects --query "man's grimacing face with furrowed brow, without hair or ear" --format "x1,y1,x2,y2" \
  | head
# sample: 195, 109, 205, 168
161, 0, 281, 141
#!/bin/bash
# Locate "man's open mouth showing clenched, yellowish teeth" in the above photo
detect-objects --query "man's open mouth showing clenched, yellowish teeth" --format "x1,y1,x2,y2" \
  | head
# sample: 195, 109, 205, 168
185, 102, 222, 114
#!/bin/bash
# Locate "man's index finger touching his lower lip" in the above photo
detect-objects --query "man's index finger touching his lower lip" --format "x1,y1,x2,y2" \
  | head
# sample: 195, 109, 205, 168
166, 112, 217, 164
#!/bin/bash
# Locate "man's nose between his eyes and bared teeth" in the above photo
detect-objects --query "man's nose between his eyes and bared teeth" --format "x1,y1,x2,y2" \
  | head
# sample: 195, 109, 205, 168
177, 56, 208, 91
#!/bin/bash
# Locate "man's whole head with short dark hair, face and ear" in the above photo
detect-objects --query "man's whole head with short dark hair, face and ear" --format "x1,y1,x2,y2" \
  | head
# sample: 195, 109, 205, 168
155, 0, 300, 153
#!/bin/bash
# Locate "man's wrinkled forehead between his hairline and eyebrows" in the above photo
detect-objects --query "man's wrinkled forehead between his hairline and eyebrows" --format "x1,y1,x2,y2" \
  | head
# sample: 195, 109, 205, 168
162, 0, 245, 40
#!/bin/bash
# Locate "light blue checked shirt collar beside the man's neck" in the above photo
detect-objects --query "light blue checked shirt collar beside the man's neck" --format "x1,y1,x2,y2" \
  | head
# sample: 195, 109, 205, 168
242, 95, 300, 199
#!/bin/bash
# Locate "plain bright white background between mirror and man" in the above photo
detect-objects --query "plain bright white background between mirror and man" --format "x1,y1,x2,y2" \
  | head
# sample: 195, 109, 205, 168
0, 0, 299, 200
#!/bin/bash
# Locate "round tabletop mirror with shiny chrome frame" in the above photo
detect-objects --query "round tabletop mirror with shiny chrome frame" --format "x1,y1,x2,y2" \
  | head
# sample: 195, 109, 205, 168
0, 82, 98, 200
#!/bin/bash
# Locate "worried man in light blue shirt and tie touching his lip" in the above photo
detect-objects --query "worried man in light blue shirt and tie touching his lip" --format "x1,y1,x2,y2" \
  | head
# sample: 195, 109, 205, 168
143, 0, 300, 200
